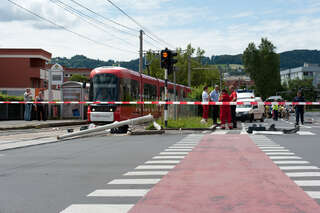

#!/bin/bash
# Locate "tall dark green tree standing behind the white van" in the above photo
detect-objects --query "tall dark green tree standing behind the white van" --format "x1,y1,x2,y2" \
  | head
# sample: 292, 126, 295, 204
242, 38, 281, 99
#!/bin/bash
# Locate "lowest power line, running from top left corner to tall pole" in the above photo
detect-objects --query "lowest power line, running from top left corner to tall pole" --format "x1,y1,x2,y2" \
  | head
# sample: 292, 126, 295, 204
8, 0, 137, 54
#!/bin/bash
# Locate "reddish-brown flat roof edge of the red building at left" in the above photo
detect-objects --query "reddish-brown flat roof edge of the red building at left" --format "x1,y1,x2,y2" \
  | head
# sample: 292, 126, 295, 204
0, 48, 52, 61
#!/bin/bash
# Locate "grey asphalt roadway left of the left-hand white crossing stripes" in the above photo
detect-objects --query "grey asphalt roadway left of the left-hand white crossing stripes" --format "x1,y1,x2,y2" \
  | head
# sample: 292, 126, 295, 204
0, 135, 183, 213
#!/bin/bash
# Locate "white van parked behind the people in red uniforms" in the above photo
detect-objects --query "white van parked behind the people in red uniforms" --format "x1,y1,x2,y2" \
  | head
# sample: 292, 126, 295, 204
236, 97, 264, 122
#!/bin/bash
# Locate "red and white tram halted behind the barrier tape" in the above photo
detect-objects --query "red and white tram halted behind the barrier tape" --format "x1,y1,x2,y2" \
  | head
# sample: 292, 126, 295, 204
88, 67, 191, 123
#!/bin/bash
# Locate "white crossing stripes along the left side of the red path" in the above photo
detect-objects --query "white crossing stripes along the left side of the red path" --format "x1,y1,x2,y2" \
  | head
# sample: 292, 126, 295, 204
61, 134, 204, 213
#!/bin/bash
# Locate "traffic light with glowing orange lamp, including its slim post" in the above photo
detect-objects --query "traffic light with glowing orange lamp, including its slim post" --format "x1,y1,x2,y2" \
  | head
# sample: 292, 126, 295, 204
161, 48, 178, 128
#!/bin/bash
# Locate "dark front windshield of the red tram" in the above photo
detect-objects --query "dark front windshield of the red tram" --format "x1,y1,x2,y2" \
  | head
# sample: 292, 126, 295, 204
90, 73, 119, 101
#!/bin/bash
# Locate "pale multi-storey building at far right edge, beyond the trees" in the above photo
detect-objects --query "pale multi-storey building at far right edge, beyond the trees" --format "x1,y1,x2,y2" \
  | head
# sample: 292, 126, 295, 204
280, 63, 320, 87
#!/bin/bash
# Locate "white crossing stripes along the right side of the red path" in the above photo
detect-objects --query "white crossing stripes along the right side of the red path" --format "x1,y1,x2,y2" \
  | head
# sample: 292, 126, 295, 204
250, 135, 320, 202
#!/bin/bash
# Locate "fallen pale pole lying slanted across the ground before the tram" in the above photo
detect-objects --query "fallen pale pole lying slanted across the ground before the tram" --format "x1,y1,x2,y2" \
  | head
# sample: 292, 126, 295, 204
57, 114, 154, 140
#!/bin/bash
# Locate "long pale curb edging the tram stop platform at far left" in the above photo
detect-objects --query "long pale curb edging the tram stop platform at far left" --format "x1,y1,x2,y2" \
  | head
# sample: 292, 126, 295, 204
0, 121, 88, 130
